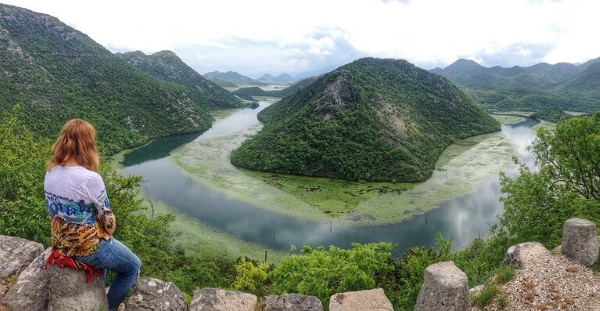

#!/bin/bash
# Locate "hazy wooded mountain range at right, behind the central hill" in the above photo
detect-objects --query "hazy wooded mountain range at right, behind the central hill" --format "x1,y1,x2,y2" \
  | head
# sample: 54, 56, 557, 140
431, 59, 600, 112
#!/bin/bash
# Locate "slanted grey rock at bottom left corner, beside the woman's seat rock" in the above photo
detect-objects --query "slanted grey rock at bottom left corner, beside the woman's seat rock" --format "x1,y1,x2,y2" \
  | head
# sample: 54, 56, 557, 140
0, 248, 52, 311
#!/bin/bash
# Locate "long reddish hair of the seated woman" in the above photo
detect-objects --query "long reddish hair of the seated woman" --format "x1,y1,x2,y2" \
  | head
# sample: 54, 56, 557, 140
46, 119, 100, 172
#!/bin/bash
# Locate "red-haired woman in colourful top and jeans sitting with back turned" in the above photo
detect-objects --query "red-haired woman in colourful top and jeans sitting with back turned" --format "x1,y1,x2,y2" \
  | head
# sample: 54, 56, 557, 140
44, 119, 142, 310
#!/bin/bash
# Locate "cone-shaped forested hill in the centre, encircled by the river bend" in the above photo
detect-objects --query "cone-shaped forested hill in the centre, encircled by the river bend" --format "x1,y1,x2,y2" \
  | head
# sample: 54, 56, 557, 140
231, 58, 500, 182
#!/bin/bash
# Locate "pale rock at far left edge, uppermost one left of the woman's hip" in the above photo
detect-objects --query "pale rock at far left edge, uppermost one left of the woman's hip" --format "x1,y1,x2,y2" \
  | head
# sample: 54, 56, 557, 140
0, 235, 44, 279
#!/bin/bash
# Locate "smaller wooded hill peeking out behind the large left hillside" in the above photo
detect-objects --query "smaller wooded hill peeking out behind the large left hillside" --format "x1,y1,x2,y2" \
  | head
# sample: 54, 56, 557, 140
116, 51, 242, 109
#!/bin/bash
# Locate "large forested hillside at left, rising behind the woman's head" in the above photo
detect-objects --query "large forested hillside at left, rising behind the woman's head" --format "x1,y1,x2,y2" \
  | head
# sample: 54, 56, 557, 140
0, 4, 212, 153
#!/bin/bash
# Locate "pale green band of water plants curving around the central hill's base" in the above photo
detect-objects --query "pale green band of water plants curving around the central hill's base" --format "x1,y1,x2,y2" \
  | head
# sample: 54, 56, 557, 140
172, 106, 525, 226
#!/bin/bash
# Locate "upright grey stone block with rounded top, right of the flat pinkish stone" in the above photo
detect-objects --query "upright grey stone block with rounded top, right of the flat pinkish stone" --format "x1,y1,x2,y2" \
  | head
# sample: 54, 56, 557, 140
415, 261, 471, 311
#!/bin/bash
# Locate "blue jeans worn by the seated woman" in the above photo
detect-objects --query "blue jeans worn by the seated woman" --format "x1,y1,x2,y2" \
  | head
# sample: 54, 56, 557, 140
75, 238, 142, 310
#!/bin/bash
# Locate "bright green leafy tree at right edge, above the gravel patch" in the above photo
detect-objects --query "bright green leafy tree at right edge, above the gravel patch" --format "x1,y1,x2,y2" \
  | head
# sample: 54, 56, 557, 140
494, 112, 600, 247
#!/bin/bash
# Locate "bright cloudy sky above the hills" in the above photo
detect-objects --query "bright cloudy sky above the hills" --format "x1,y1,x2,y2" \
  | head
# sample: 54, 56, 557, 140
0, 0, 600, 78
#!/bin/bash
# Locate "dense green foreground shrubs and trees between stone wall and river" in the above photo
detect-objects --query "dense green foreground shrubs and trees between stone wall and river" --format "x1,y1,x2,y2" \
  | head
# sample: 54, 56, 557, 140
0, 106, 600, 310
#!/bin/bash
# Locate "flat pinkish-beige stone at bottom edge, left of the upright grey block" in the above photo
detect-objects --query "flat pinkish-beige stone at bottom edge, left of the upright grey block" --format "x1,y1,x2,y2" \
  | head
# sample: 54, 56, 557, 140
329, 288, 394, 311
